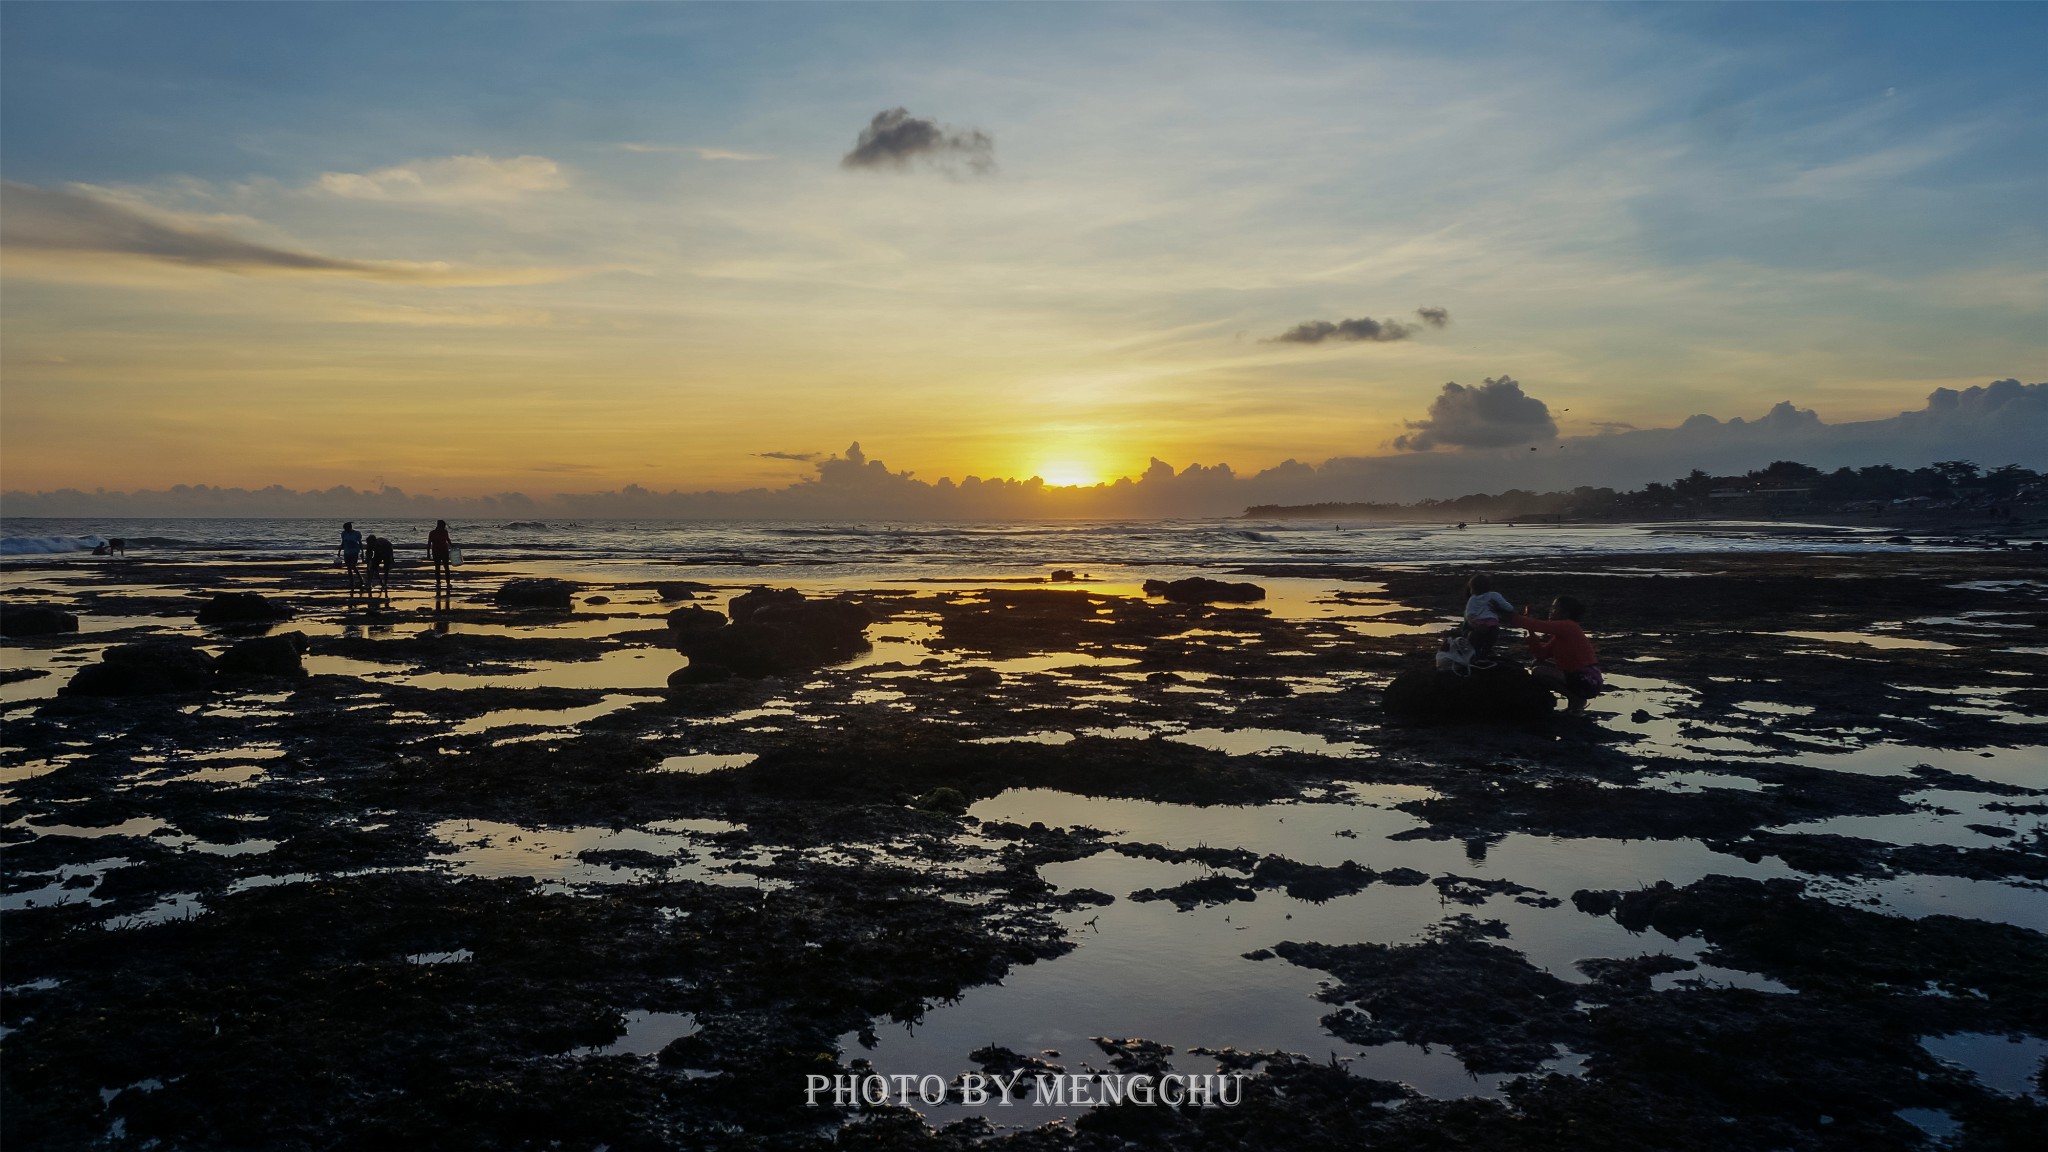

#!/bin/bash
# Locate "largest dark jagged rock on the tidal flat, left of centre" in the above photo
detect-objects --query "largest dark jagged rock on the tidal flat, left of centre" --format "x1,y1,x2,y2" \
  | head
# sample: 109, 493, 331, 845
670, 588, 874, 685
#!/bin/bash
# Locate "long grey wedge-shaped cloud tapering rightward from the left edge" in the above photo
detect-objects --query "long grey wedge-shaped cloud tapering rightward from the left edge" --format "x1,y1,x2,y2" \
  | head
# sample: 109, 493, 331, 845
0, 180, 578, 285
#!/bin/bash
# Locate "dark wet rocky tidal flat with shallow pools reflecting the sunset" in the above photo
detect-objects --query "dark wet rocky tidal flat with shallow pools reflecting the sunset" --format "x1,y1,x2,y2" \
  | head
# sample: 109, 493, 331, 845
0, 551, 2048, 1150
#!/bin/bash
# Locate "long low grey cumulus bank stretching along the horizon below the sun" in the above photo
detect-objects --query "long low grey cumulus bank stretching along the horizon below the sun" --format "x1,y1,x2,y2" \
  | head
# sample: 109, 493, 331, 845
19, 379, 2048, 519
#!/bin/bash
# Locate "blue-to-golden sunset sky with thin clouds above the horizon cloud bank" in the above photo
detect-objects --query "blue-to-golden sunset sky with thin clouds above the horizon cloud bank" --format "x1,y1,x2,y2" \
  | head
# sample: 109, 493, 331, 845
0, 2, 2048, 508
